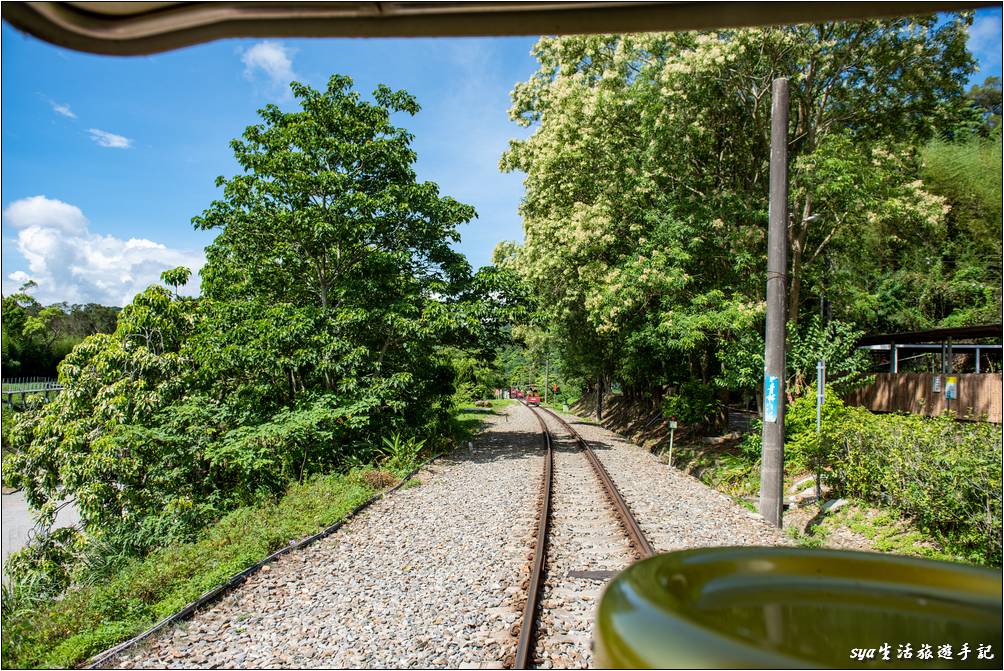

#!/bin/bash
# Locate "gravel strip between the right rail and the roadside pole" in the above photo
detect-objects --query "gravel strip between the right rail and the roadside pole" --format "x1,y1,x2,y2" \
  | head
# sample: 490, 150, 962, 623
546, 405, 791, 552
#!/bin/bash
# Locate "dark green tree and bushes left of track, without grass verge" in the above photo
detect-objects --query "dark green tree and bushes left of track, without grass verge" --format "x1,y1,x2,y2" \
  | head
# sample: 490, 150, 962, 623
5, 75, 479, 549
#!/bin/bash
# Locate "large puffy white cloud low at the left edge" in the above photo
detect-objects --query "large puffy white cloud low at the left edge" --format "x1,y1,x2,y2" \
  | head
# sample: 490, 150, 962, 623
3, 196, 205, 305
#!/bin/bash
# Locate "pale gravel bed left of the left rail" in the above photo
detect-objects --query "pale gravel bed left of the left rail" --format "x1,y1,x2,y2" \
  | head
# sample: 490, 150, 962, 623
111, 406, 543, 668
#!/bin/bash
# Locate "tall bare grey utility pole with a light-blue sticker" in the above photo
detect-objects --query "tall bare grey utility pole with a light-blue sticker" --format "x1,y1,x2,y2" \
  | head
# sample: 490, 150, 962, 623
760, 77, 788, 527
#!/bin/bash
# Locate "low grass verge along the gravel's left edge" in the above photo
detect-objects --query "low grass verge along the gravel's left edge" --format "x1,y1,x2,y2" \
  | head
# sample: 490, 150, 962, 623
2, 470, 377, 668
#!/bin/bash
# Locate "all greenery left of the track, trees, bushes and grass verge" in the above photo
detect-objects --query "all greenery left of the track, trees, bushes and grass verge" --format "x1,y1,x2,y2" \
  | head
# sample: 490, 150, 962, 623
3, 75, 520, 666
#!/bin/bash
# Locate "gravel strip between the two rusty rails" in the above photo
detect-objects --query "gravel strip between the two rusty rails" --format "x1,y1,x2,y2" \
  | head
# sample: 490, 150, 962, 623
534, 412, 635, 669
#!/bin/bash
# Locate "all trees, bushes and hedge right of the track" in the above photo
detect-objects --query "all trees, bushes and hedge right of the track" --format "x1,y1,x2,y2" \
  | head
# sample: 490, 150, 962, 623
485, 12, 1002, 566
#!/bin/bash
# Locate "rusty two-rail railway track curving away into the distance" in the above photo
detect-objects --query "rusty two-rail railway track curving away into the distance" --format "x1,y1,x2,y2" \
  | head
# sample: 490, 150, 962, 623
512, 403, 655, 669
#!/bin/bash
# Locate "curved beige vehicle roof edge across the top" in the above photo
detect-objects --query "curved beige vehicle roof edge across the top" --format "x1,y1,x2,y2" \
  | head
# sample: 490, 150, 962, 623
2, 0, 998, 56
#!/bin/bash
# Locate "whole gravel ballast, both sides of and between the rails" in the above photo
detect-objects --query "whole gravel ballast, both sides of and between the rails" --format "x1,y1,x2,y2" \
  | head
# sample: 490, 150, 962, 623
106, 405, 787, 668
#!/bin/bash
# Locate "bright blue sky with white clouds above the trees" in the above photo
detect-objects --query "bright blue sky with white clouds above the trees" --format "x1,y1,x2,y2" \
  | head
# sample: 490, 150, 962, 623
0, 8, 1001, 305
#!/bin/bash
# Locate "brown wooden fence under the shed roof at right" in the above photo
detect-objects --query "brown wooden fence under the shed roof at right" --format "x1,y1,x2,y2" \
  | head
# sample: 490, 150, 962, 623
844, 373, 1004, 424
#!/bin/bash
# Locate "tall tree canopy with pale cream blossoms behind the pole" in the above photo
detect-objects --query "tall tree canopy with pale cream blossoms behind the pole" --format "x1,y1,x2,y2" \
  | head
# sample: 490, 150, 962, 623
500, 15, 974, 401
